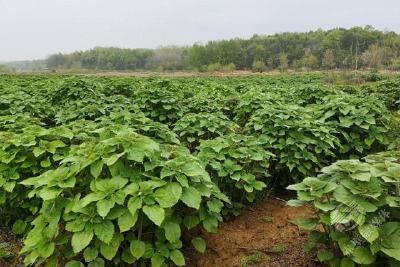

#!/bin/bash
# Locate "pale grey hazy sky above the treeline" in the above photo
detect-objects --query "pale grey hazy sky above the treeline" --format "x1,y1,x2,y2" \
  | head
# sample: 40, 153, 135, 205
0, 0, 400, 61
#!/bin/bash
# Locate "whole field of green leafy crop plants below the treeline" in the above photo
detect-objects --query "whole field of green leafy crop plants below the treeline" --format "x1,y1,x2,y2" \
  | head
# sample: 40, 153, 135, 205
0, 73, 400, 267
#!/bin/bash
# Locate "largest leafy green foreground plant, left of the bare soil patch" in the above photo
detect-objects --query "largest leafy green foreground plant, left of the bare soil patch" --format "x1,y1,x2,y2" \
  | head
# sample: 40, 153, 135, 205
15, 128, 229, 266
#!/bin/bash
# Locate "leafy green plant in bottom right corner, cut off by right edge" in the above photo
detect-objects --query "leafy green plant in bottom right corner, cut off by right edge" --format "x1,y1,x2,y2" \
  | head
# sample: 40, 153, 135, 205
288, 152, 400, 266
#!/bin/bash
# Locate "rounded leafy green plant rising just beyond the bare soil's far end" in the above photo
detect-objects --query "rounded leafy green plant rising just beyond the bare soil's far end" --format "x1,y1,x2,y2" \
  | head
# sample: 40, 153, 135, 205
245, 104, 340, 184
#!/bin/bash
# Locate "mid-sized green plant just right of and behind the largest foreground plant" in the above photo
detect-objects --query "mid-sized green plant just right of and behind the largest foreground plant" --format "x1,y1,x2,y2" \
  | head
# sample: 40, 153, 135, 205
198, 134, 274, 217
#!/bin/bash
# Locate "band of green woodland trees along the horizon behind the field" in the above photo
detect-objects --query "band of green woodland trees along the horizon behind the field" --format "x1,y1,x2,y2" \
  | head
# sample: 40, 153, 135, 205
40, 26, 400, 71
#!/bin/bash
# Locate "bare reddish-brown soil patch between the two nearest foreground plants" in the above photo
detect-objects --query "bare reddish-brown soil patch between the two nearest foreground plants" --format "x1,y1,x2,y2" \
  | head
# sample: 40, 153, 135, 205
187, 198, 318, 267
